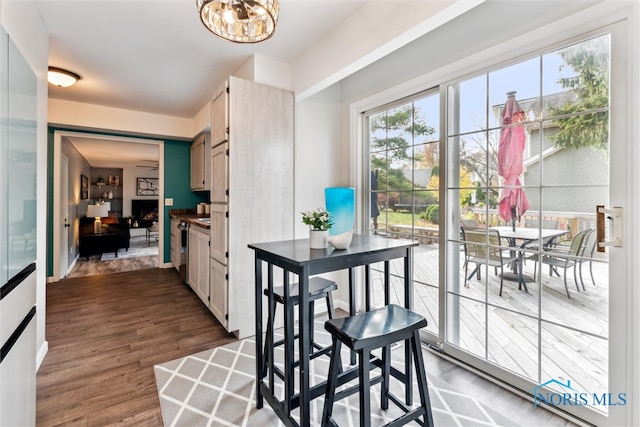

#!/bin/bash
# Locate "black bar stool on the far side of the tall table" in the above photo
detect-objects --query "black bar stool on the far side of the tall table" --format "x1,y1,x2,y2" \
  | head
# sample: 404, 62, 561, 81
262, 277, 338, 379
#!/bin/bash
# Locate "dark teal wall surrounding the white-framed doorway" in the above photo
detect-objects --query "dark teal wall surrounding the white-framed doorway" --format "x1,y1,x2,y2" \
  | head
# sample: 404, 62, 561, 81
47, 126, 209, 277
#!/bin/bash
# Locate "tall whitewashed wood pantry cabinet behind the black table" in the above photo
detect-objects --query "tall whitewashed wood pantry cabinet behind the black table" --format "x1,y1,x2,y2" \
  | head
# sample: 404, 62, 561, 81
209, 77, 294, 338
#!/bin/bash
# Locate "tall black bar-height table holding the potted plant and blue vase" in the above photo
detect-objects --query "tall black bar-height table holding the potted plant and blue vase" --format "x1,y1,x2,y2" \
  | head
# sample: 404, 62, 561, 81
248, 234, 418, 426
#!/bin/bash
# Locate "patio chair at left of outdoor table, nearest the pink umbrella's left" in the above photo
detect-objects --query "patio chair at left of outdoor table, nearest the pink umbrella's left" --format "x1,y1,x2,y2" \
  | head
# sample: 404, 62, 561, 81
462, 227, 518, 296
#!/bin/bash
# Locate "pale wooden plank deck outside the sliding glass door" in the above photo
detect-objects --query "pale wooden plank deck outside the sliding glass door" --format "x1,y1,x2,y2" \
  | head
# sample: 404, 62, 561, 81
362, 244, 608, 400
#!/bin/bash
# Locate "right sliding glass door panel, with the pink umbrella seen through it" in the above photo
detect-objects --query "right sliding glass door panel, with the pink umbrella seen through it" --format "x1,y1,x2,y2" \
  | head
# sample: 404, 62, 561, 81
442, 27, 632, 425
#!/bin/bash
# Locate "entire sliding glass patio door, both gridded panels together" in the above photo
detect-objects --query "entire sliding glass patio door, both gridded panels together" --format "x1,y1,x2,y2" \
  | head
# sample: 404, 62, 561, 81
364, 26, 629, 424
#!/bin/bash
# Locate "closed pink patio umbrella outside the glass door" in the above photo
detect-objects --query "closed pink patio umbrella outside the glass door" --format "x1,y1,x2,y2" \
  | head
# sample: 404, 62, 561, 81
498, 92, 529, 230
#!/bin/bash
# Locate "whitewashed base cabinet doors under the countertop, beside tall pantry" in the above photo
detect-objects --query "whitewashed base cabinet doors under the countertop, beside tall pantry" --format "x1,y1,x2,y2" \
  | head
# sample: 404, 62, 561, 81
189, 225, 209, 307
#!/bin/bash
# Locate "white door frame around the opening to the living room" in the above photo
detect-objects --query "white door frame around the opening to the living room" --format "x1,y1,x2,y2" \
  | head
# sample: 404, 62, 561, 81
51, 130, 164, 282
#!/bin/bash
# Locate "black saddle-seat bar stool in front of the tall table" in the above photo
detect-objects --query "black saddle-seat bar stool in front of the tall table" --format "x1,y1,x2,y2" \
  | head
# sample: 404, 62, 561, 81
322, 304, 433, 427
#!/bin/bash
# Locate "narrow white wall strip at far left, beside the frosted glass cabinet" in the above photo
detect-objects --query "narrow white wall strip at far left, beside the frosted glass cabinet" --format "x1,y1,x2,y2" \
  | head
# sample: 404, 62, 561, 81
0, 0, 49, 366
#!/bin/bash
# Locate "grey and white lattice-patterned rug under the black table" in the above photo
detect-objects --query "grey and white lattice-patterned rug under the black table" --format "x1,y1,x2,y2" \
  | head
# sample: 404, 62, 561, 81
154, 329, 513, 427
